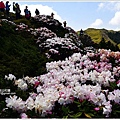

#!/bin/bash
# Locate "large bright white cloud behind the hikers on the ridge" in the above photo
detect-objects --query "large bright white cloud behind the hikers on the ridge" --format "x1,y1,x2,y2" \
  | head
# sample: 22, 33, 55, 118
10, 2, 63, 22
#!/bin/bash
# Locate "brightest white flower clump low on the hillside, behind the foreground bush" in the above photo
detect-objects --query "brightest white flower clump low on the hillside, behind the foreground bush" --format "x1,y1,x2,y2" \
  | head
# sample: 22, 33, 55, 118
39, 37, 80, 58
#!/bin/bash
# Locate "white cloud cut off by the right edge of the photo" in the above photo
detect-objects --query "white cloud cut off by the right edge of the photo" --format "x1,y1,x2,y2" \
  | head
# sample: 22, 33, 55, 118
109, 11, 120, 25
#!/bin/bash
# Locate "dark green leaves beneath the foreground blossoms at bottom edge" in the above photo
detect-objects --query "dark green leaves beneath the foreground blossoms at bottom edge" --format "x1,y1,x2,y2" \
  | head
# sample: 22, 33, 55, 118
48, 99, 104, 118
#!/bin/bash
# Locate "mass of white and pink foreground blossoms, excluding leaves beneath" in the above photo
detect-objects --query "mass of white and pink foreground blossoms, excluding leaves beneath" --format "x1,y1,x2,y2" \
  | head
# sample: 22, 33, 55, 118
6, 50, 120, 117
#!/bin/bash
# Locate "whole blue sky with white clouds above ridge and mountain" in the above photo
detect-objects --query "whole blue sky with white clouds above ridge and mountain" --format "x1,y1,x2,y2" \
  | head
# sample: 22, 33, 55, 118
4, 0, 120, 31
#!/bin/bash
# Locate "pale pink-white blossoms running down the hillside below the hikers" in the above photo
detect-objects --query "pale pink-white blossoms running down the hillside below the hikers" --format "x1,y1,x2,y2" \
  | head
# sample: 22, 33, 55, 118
1, 15, 81, 58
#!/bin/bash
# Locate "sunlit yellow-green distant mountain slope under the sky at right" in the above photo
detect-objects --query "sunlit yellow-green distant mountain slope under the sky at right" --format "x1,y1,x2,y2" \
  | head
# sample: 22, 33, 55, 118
85, 28, 120, 45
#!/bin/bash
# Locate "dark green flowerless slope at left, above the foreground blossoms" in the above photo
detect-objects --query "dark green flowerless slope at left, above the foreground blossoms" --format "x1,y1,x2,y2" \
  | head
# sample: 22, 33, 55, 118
0, 20, 52, 77
